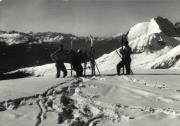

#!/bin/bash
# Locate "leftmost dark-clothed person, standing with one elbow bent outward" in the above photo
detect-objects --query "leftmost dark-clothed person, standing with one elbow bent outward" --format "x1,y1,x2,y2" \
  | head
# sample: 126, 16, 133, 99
51, 44, 67, 78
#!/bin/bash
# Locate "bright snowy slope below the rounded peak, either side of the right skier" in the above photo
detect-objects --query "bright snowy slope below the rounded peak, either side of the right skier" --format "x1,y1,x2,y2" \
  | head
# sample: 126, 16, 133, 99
97, 42, 180, 71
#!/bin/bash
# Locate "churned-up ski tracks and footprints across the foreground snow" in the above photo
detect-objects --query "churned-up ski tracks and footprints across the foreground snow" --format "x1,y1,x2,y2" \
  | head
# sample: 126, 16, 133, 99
0, 76, 180, 126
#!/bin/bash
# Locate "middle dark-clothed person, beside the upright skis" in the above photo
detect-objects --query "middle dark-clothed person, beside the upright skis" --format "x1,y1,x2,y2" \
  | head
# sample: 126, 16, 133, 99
72, 49, 83, 77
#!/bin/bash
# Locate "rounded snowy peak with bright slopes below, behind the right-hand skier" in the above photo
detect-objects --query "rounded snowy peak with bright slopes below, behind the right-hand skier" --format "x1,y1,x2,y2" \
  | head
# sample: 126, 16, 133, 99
97, 17, 180, 70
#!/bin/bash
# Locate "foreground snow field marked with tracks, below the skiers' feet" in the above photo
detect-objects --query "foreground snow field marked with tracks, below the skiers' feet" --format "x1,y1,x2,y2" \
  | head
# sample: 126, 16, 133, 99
0, 75, 180, 126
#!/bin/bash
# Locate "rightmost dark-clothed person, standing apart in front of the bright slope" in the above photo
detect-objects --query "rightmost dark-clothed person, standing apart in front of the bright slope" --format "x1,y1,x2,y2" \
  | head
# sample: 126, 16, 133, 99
116, 36, 132, 75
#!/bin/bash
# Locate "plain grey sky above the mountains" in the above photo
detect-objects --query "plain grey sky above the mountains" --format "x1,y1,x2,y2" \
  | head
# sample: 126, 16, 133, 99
0, 0, 180, 37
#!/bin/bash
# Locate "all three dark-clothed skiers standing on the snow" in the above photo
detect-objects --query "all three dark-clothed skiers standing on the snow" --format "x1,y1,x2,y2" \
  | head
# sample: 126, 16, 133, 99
51, 35, 132, 78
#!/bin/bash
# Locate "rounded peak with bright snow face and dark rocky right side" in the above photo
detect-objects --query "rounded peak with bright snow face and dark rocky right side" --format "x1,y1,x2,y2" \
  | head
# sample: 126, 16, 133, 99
128, 17, 180, 52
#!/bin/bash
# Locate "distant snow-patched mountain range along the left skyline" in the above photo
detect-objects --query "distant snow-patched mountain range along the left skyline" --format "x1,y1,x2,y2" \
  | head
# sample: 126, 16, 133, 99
0, 31, 78, 45
